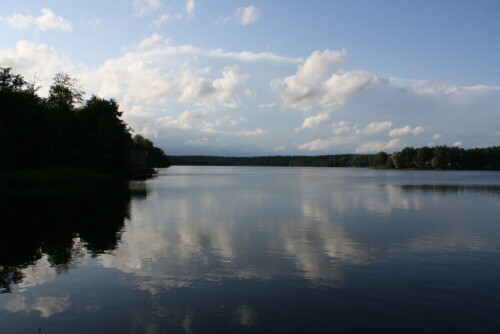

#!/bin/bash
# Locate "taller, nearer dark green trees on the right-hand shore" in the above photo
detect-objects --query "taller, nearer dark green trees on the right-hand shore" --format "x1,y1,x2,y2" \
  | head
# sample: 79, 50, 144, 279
373, 146, 500, 170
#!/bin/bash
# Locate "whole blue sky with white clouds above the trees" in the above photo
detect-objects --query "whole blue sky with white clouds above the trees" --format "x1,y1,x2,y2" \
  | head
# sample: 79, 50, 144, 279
0, 0, 500, 156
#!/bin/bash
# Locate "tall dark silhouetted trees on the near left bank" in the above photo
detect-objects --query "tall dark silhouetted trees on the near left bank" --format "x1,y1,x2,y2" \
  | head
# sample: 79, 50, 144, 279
0, 68, 168, 176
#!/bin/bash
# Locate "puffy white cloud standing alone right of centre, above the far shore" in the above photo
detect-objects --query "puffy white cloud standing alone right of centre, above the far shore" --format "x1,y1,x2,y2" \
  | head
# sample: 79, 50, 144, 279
272, 50, 383, 111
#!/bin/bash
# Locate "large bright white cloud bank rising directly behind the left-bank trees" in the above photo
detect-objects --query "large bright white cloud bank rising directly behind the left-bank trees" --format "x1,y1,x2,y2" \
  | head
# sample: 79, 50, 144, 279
0, 33, 306, 135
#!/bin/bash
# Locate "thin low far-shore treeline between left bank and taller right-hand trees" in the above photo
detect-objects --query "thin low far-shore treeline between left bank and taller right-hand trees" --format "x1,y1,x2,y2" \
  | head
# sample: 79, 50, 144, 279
170, 154, 373, 167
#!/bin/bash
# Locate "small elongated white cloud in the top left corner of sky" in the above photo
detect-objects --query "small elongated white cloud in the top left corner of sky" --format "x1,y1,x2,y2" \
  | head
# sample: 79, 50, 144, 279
5, 8, 73, 31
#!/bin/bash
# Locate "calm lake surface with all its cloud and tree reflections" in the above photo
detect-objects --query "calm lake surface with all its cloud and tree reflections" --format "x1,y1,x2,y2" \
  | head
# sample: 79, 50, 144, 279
0, 166, 500, 334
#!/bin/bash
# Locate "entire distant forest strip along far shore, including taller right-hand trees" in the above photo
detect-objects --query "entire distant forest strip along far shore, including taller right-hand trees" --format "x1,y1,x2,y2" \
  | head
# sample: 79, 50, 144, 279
170, 146, 500, 170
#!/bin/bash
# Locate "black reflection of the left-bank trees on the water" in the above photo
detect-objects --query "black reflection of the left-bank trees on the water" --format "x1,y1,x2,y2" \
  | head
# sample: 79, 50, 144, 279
0, 184, 131, 293
